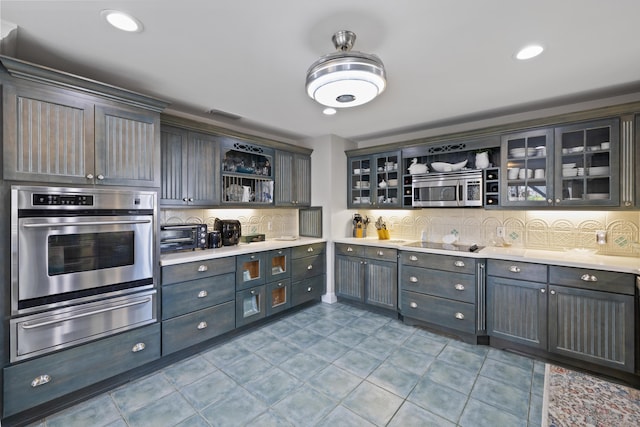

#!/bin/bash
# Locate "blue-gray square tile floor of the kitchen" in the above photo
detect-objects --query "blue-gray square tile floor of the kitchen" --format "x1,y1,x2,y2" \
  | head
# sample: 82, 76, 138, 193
26, 303, 544, 427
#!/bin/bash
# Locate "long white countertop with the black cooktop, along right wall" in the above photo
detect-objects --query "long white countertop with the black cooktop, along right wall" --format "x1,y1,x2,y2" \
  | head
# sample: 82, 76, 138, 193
334, 237, 640, 274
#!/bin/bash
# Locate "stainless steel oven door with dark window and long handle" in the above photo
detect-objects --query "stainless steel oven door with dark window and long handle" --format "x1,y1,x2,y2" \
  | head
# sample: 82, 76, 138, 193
16, 215, 153, 301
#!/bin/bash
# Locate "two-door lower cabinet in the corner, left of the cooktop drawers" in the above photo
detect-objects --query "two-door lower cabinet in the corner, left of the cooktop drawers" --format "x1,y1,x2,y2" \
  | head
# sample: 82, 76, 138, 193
335, 243, 398, 310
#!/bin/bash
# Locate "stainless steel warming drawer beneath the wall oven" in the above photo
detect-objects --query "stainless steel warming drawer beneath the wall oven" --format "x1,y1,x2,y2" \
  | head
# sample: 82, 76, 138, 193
10, 290, 156, 363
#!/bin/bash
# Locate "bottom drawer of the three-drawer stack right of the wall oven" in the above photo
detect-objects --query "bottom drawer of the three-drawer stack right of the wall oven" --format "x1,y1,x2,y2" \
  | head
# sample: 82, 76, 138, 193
162, 301, 236, 355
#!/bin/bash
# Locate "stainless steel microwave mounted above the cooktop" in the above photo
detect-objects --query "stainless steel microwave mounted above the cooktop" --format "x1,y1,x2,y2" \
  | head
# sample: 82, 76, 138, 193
411, 170, 483, 207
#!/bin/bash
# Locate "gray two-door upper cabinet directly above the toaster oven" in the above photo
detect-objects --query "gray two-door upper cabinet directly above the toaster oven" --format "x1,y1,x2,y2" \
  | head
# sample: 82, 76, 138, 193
160, 126, 220, 206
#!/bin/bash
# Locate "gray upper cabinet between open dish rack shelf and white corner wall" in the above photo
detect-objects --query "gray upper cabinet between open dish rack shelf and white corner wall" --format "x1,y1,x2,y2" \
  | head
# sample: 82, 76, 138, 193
274, 150, 311, 207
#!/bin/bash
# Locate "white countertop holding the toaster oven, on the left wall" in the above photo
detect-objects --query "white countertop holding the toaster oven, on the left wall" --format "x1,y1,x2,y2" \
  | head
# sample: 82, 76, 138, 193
160, 237, 326, 266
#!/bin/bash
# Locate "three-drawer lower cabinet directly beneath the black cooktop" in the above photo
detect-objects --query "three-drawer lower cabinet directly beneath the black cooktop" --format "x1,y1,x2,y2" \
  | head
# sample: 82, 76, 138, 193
400, 251, 484, 338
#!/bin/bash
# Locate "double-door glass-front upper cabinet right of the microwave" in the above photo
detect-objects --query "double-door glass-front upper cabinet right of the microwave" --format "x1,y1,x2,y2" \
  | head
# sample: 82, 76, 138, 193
501, 119, 619, 207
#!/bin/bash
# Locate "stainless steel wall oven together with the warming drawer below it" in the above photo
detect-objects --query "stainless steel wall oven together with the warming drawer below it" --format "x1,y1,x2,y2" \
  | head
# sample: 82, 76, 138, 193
10, 186, 157, 362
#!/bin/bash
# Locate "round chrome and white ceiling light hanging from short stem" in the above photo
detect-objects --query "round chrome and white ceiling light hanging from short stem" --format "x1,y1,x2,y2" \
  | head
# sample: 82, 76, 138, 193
307, 31, 387, 108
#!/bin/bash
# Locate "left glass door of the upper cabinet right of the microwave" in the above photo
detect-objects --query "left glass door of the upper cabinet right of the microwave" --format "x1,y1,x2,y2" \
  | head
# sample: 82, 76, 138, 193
501, 129, 554, 206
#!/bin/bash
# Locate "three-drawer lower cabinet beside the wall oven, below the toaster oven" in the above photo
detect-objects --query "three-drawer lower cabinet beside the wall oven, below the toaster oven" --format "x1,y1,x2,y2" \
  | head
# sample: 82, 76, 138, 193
161, 257, 236, 355
